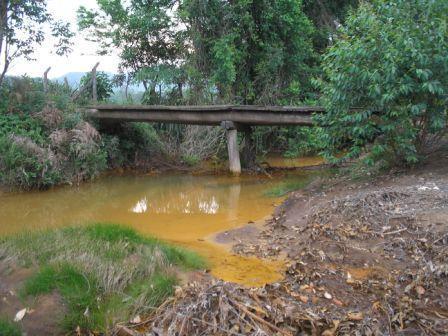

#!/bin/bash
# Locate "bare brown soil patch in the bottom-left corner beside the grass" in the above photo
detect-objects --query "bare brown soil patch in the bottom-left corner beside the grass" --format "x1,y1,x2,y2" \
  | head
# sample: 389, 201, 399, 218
0, 263, 66, 336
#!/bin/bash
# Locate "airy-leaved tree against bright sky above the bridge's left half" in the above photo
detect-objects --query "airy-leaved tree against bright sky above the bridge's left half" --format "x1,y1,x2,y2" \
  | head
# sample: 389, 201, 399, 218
78, 0, 179, 89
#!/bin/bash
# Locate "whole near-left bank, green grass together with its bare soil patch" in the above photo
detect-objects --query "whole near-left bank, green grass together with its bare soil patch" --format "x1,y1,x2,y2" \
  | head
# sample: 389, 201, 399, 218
0, 224, 206, 336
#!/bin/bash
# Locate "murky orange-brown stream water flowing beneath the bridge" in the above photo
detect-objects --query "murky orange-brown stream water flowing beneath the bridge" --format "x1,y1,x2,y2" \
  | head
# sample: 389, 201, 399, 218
0, 159, 322, 286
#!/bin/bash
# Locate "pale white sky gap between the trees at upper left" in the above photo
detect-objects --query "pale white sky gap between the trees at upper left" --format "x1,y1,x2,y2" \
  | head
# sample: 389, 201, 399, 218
8, 0, 119, 78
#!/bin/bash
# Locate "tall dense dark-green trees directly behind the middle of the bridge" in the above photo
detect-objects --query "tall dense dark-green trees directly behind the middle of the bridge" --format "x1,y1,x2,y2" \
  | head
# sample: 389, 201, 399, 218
180, 0, 314, 104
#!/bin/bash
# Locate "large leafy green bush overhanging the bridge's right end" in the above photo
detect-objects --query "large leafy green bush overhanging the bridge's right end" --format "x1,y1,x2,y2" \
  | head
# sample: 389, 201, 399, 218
319, 0, 448, 166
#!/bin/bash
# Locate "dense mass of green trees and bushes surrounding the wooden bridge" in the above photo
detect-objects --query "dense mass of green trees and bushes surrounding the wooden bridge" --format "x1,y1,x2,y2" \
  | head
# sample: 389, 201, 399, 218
0, 0, 448, 188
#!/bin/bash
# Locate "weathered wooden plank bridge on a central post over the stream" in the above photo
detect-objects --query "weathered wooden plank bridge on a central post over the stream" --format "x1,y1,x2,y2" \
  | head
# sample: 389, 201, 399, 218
87, 105, 324, 174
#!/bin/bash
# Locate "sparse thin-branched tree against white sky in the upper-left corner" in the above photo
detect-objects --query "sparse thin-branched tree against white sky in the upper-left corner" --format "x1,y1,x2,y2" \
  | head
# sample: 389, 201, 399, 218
0, 0, 73, 86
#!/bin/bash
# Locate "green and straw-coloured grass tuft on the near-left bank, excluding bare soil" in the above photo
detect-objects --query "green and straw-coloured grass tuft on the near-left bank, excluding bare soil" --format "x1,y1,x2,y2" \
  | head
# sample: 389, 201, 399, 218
0, 223, 206, 332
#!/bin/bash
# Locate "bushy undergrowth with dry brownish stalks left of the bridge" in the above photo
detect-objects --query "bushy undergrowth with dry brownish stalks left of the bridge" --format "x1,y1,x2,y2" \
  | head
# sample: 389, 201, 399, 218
0, 77, 107, 189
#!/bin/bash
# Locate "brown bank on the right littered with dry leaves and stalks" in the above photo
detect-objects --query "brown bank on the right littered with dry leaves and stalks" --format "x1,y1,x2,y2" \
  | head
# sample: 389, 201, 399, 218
135, 158, 448, 336
